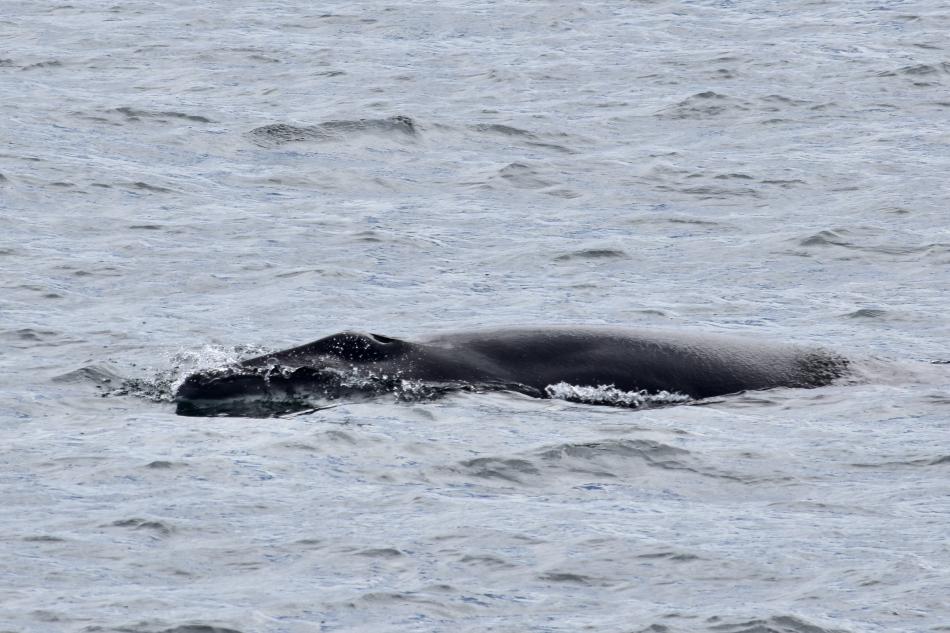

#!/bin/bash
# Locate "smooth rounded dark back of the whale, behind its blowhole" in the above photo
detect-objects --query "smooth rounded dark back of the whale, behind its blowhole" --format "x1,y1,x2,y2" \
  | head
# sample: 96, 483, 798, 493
424, 327, 846, 398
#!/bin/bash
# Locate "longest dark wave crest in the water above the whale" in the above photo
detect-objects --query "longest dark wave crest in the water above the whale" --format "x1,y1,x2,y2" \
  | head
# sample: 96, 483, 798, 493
249, 115, 418, 147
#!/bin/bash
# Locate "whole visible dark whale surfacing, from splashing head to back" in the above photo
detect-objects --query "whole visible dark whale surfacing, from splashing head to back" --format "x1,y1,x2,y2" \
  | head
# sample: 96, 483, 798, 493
175, 327, 848, 417
